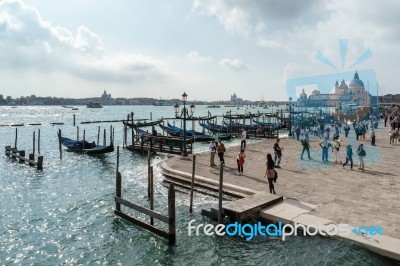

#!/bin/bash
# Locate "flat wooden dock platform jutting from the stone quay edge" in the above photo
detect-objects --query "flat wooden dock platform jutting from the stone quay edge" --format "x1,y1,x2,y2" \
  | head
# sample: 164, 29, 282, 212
222, 193, 283, 222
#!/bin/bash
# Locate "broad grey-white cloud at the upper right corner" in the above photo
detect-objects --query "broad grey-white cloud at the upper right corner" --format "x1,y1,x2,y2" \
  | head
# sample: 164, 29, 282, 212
193, 0, 400, 54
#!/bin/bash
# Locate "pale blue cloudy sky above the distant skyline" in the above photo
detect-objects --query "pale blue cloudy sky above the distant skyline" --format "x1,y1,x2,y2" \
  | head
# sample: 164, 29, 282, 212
0, 0, 400, 101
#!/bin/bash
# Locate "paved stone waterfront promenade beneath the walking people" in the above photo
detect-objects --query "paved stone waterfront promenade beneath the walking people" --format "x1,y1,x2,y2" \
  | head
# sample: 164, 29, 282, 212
162, 124, 400, 258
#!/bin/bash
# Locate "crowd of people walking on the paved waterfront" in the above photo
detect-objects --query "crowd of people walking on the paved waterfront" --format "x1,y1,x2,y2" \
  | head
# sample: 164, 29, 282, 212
205, 109, 400, 194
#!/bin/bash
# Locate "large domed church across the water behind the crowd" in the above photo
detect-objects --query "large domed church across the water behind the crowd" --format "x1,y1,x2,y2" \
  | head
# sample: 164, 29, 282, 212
297, 71, 371, 112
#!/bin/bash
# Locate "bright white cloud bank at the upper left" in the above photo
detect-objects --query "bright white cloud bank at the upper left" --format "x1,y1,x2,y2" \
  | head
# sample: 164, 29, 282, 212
0, 0, 170, 83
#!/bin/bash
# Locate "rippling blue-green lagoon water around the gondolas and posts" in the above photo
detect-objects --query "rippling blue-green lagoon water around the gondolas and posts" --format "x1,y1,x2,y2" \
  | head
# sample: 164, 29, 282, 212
0, 106, 393, 265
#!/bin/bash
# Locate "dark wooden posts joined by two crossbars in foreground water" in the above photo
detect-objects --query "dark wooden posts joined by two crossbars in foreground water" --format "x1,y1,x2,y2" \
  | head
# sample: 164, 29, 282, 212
114, 147, 176, 245
